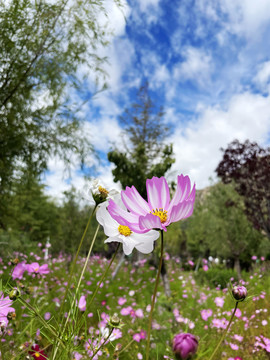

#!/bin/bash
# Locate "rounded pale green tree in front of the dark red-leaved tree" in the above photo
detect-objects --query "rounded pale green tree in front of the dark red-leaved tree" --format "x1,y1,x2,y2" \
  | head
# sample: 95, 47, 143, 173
186, 183, 264, 268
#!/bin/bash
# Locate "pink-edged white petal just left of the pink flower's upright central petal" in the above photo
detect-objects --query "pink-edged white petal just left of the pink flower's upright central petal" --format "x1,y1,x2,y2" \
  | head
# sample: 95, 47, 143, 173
121, 186, 152, 215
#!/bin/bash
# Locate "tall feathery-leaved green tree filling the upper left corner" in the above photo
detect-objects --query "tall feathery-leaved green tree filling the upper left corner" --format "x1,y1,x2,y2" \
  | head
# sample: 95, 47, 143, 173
0, 0, 118, 228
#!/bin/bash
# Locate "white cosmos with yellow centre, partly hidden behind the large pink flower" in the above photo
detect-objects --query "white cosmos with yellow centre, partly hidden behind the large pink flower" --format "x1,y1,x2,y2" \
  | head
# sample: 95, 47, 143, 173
97, 194, 159, 255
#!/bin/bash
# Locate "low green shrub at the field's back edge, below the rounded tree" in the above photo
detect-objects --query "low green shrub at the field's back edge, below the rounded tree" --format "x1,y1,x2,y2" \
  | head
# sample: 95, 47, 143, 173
195, 266, 238, 289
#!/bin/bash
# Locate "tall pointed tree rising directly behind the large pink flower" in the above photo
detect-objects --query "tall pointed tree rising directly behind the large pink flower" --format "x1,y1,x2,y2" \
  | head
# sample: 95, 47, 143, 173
108, 83, 175, 198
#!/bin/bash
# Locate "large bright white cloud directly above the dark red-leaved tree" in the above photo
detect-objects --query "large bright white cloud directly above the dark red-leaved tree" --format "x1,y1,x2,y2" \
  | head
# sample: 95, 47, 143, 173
170, 93, 270, 188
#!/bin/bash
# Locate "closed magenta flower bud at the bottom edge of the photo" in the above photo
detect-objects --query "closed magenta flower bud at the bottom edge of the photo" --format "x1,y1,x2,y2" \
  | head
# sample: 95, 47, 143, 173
173, 333, 198, 360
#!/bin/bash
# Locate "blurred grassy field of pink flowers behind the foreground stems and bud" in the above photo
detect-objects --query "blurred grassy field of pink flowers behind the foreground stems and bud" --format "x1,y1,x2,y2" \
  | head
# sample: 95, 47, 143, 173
0, 249, 270, 360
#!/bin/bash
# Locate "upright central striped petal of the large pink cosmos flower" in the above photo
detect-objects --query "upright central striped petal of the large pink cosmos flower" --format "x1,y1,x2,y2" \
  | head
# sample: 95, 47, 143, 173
146, 176, 170, 211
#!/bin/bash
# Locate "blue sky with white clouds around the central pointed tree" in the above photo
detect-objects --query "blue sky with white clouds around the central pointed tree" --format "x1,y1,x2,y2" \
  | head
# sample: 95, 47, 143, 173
45, 0, 270, 198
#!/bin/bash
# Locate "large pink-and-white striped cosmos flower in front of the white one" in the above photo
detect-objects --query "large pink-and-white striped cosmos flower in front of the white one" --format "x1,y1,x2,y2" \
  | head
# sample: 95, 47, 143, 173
108, 175, 196, 233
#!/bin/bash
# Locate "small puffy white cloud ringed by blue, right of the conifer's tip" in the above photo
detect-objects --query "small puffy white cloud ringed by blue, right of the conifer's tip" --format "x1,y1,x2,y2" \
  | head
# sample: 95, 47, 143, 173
173, 46, 211, 85
